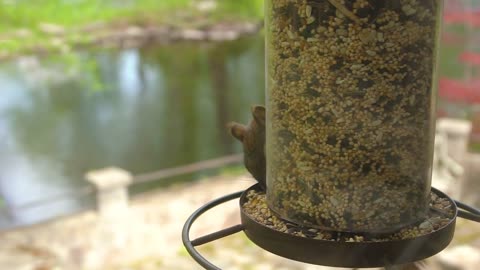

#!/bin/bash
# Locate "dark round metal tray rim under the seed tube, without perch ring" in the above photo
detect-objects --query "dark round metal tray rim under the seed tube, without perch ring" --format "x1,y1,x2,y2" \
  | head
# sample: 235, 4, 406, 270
240, 185, 457, 268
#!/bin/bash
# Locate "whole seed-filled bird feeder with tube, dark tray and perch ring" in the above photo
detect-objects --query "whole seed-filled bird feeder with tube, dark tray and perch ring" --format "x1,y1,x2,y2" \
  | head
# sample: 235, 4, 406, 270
183, 0, 480, 269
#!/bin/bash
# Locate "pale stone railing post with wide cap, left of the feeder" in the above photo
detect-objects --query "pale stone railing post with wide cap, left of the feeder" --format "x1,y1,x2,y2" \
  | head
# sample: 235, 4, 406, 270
86, 167, 132, 217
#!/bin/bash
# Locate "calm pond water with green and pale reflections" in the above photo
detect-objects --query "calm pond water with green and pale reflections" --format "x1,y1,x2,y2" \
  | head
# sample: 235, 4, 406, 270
0, 37, 264, 229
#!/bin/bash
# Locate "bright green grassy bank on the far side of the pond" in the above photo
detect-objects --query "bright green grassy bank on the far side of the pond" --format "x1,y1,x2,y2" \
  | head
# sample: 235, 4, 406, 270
0, 0, 263, 56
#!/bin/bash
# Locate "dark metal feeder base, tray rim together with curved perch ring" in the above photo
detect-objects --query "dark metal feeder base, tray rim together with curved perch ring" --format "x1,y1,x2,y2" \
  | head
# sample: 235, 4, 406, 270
182, 185, 480, 269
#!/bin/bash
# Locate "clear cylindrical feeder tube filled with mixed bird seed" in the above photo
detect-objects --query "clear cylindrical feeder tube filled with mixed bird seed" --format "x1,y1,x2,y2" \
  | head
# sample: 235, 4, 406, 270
266, 0, 442, 233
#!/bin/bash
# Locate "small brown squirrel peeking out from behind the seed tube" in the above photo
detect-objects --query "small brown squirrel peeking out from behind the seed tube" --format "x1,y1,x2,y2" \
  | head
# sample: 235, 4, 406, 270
228, 105, 267, 191
